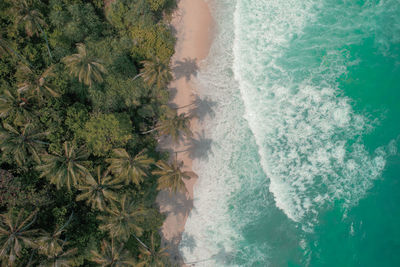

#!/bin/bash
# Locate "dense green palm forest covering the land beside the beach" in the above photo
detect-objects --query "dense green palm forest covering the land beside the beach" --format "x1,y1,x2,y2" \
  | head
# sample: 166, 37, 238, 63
0, 0, 191, 266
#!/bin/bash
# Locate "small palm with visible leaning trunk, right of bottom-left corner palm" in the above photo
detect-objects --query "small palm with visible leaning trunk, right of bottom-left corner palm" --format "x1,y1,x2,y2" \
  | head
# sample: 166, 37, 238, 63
36, 214, 73, 256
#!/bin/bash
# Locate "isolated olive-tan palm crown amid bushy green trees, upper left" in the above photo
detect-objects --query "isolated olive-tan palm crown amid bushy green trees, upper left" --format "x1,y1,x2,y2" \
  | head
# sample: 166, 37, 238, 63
63, 43, 107, 87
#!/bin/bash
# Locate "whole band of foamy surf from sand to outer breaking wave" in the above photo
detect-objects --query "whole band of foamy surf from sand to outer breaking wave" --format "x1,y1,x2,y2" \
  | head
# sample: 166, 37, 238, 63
180, 0, 397, 266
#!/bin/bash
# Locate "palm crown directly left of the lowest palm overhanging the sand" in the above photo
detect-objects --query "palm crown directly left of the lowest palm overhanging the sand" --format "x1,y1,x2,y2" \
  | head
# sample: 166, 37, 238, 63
106, 148, 154, 185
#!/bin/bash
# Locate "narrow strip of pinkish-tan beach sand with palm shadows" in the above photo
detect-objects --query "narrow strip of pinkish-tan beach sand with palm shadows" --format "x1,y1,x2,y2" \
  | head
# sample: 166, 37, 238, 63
157, 0, 213, 265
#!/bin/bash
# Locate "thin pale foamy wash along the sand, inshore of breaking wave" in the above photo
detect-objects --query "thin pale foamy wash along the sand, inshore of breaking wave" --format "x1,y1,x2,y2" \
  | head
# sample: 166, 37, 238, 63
180, 2, 245, 267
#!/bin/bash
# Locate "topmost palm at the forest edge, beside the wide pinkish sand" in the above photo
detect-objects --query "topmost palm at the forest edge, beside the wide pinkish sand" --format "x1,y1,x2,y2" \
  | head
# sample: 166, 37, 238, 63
141, 57, 172, 88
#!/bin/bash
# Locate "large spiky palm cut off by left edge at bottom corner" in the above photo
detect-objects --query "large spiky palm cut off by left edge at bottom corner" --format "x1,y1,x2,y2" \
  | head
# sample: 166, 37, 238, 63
0, 209, 37, 266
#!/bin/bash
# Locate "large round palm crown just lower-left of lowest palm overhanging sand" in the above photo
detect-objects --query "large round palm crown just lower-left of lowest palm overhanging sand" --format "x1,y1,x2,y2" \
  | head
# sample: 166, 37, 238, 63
98, 195, 146, 241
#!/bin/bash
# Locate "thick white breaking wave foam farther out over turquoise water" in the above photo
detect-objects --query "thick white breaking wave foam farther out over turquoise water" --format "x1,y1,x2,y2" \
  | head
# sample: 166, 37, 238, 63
234, 0, 385, 225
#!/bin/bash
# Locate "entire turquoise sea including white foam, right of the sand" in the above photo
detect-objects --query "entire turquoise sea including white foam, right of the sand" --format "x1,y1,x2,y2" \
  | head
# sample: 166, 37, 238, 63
180, 0, 400, 266
